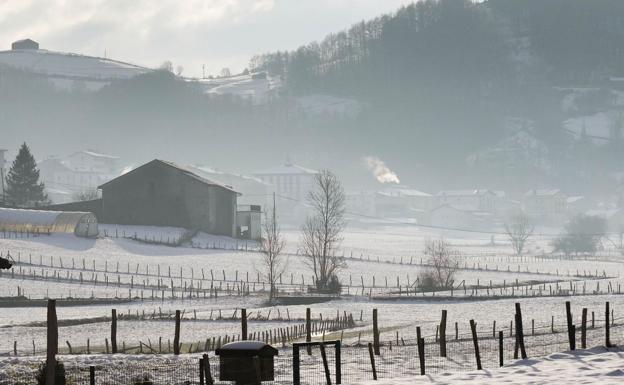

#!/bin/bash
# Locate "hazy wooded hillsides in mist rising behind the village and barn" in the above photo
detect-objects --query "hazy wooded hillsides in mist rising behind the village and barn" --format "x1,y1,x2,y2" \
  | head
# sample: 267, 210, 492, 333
0, 0, 624, 198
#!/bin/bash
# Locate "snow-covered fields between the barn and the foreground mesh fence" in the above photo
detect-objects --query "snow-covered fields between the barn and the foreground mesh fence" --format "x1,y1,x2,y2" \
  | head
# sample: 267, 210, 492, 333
0, 225, 624, 380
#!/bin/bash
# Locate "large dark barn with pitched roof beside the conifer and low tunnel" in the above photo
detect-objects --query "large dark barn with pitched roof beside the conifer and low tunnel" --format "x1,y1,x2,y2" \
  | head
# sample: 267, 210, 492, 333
99, 159, 239, 237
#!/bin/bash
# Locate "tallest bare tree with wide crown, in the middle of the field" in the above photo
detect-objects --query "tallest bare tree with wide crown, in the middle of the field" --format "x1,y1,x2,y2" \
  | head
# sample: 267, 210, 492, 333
301, 170, 346, 292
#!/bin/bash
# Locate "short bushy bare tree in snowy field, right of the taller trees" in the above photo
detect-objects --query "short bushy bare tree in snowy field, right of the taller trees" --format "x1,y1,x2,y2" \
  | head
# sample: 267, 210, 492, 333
419, 239, 459, 289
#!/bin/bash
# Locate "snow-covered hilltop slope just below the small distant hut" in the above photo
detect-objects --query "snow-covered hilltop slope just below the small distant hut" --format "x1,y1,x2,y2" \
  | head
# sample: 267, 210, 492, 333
0, 49, 152, 80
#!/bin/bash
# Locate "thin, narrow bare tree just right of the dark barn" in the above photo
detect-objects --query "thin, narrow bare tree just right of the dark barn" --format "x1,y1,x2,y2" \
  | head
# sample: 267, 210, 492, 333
261, 196, 287, 301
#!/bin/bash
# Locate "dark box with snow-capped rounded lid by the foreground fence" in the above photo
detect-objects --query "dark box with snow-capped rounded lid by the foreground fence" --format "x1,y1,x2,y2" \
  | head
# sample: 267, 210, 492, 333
215, 341, 277, 385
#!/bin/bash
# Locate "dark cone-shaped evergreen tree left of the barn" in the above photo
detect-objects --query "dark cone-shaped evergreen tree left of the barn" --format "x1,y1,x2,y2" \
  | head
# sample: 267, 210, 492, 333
6, 143, 48, 207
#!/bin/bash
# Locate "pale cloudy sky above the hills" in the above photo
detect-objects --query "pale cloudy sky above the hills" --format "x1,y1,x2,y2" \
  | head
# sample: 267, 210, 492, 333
0, 0, 420, 76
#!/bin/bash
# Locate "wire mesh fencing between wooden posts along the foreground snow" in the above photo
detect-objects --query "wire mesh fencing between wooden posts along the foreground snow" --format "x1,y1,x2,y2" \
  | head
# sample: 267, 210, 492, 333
0, 319, 624, 385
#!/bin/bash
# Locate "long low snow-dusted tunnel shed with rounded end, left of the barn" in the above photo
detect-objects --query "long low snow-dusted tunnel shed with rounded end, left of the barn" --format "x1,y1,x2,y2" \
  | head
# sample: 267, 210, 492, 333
0, 208, 98, 238
